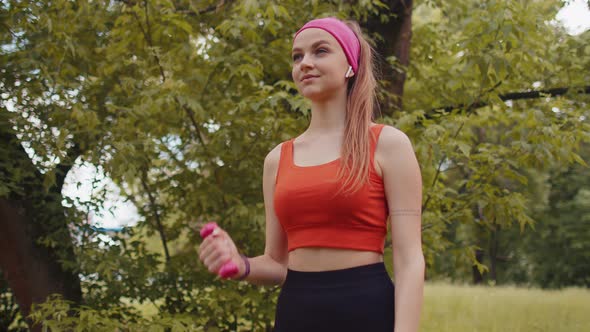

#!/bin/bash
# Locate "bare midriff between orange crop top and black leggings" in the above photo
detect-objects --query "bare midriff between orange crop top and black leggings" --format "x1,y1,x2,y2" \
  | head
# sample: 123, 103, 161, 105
288, 247, 383, 272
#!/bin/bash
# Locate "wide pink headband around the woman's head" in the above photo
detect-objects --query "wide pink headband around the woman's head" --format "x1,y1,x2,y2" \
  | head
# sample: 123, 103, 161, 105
293, 17, 361, 73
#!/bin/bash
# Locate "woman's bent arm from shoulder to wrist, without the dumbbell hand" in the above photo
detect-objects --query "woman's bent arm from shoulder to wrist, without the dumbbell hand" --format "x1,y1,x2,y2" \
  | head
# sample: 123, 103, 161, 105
232, 144, 289, 285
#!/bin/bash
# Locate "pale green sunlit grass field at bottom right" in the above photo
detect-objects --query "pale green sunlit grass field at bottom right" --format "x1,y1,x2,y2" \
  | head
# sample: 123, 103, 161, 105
420, 283, 590, 332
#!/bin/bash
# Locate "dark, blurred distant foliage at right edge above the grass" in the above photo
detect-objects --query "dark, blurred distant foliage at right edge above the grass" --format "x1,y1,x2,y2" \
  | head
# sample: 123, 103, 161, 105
523, 146, 590, 287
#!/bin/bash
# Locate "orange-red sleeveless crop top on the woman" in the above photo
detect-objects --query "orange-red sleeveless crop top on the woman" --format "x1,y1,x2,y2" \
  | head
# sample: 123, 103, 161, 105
273, 124, 389, 253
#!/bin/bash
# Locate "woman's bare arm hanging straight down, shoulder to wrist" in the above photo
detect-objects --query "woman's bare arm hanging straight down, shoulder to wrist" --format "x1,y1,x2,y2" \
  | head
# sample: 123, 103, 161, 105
378, 126, 425, 332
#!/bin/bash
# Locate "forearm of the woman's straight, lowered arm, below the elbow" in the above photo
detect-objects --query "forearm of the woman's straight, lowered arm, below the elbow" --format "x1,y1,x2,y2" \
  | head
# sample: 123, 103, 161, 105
394, 256, 425, 332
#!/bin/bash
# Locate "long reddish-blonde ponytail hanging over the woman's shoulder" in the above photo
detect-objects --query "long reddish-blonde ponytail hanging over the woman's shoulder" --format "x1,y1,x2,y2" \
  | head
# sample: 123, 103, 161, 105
337, 21, 377, 197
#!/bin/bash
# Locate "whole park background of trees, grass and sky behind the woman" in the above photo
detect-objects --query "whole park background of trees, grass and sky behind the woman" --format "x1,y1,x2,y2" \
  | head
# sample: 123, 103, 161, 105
0, 0, 590, 331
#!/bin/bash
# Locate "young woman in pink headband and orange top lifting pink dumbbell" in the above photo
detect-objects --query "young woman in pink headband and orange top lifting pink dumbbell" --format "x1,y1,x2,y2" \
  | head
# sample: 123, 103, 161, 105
199, 18, 424, 332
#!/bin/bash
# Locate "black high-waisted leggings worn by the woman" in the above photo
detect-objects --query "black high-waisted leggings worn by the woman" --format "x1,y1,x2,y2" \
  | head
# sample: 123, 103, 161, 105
273, 263, 394, 332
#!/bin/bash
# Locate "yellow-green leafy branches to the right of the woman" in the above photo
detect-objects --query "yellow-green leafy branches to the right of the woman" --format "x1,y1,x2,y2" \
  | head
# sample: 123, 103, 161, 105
410, 1, 590, 280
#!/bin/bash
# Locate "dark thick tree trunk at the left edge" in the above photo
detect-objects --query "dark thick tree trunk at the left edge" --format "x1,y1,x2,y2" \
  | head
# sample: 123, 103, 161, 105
0, 121, 82, 331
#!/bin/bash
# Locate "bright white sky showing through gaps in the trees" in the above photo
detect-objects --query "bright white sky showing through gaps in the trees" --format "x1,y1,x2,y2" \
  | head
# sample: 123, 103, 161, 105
62, 0, 590, 228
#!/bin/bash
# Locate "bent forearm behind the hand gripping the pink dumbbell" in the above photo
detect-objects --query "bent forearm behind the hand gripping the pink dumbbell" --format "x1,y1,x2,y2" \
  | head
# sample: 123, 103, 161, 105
238, 254, 287, 286
